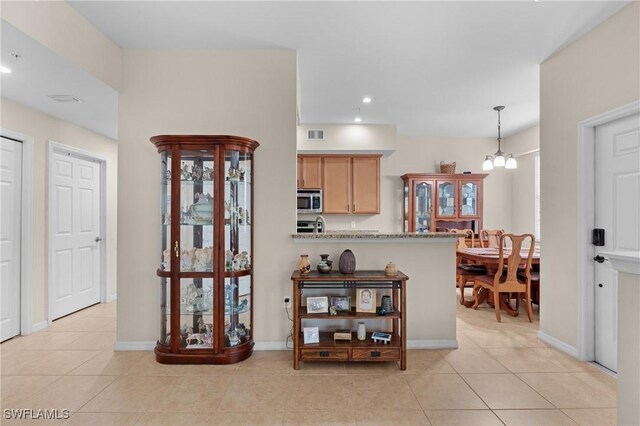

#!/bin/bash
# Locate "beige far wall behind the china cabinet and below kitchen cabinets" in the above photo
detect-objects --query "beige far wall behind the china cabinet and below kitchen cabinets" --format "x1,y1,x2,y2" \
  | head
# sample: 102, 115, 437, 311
298, 132, 511, 232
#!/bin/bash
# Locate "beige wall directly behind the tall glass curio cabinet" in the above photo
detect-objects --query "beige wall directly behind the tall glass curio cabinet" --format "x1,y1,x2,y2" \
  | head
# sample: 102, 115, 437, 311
117, 50, 298, 348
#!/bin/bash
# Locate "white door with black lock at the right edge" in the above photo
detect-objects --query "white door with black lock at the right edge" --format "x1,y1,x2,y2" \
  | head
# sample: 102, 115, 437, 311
595, 114, 640, 371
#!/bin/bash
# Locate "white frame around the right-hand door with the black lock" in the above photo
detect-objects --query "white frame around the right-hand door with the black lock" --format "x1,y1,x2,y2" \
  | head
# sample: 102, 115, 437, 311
577, 101, 640, 361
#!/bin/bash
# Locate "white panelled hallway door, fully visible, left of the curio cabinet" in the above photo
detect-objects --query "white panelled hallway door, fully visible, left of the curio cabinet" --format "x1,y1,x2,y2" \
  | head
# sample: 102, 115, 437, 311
50, 152, 102, 319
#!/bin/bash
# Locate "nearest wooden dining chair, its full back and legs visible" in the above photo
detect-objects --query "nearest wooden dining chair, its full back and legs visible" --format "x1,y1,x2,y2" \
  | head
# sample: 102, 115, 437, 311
473, 234, 535, 322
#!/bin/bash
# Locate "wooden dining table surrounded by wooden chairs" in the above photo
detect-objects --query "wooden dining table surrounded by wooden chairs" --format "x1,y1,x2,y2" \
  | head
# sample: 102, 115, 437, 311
456, 247, 540, 317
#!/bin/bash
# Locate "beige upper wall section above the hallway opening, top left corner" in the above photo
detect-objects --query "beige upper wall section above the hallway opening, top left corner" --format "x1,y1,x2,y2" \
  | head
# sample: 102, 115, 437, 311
0, 1, 122, 90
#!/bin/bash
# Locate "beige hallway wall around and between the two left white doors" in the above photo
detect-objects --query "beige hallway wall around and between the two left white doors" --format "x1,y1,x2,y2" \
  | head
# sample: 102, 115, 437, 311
1, 99, 118, 325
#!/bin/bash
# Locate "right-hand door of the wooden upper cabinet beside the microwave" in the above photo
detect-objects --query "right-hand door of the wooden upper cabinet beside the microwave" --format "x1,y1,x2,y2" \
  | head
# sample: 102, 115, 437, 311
351, 157, 380, 214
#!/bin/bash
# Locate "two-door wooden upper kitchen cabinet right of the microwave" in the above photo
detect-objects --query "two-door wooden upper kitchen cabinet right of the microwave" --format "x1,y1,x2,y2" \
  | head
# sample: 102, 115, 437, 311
322, 155, 381, 214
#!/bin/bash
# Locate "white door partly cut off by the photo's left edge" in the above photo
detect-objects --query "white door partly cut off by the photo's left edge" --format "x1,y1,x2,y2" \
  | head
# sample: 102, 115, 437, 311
0, 138, 22, 341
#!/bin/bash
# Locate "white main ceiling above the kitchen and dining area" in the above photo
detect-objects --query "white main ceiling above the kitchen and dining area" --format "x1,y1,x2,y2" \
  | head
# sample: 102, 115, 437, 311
2, 1, 628, 137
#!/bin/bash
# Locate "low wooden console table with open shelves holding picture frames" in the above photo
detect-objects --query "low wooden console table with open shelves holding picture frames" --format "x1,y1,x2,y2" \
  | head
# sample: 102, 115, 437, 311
291, 271, 409, 370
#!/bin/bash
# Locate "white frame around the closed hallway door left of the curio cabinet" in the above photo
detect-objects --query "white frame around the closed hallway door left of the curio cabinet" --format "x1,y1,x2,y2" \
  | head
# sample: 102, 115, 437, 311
47, 139, 110, 325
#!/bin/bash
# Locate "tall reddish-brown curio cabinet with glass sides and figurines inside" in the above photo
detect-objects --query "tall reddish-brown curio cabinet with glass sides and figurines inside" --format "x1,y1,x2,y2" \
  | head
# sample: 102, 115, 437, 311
151, 135, 258, 364
